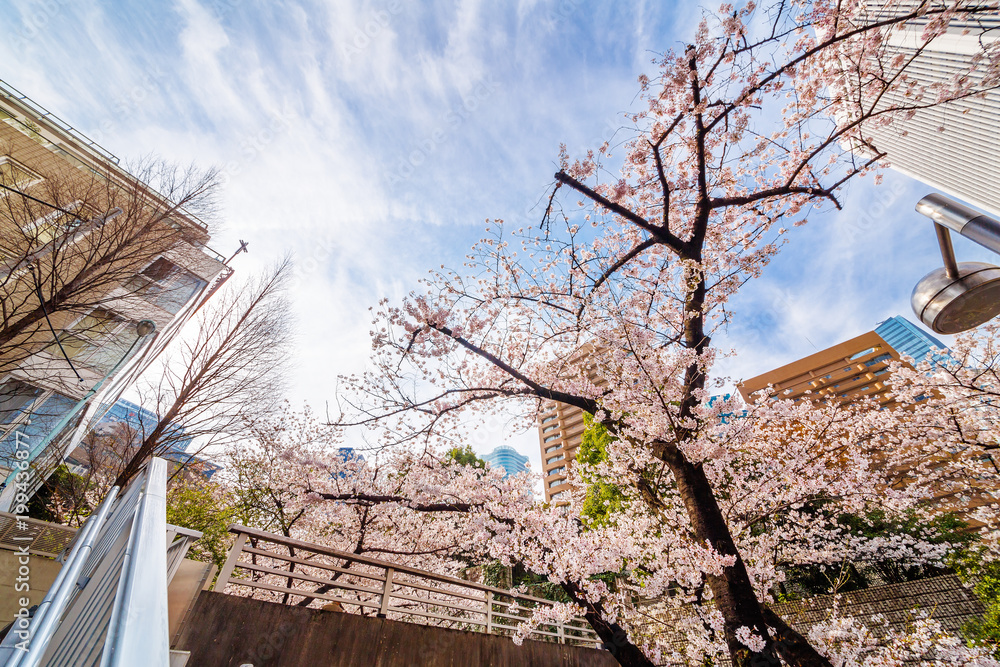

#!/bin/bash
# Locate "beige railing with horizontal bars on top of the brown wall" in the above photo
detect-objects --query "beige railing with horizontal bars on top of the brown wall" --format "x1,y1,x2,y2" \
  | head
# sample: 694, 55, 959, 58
214, 525, 600, 647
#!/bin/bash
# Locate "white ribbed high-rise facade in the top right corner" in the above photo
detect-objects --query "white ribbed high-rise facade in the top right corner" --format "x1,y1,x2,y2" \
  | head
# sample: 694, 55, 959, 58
845, 0, 1000, 215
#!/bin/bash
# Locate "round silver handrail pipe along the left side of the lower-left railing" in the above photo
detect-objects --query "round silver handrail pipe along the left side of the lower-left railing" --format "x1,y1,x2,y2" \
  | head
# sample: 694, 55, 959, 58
6, 486, 119, 667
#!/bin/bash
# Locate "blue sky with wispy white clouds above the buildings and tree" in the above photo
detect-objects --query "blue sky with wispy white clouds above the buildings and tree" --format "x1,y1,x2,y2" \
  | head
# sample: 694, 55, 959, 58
0, 0, 993, 467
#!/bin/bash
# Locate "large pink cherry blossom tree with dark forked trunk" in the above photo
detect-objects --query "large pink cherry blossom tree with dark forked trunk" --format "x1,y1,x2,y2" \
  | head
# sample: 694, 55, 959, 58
313, 0, 1000, 665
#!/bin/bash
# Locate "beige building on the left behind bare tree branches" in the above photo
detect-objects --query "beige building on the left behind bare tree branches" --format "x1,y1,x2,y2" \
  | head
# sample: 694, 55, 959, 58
0, 81, 231, 510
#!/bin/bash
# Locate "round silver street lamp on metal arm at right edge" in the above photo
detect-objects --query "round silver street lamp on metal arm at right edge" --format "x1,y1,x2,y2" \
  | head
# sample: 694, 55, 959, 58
910, 194, 1000, 334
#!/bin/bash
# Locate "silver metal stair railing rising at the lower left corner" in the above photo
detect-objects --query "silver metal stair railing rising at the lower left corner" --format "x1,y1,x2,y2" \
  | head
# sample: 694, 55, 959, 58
0, 458, 201, 667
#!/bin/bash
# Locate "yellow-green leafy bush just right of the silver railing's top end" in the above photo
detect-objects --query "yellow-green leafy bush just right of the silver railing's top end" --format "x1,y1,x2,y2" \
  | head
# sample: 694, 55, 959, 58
167, 480, 236, 568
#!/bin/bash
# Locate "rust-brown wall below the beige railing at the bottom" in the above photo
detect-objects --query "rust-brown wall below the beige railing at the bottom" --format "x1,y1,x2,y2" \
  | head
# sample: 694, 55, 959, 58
174, 591, 618, 667
